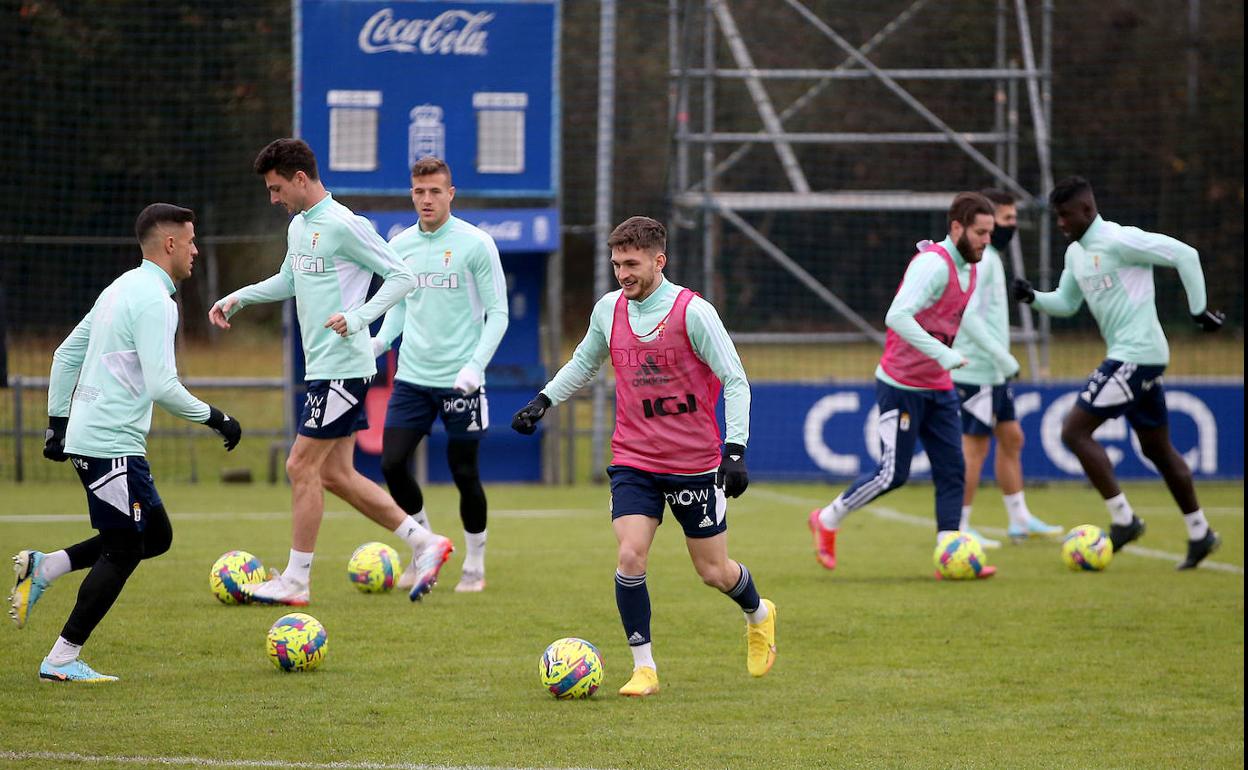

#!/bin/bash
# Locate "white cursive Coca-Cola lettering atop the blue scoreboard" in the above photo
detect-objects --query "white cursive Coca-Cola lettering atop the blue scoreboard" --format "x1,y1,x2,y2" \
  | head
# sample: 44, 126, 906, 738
359, 7, 494, 56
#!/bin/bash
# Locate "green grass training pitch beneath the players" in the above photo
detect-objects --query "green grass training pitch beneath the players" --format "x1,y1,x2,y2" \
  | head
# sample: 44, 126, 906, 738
0, 483, 1244, 768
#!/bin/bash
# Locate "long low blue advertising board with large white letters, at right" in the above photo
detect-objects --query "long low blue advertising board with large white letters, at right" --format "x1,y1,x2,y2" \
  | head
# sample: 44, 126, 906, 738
743, 379, 1244, 479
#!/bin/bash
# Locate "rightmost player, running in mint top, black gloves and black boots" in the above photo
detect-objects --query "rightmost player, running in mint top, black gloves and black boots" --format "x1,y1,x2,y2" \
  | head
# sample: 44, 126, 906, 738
1013, 176, 1224, 569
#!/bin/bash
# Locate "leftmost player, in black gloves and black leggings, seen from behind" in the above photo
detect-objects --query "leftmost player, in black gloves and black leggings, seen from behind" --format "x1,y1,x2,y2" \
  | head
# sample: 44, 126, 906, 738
10, 203, 242, 681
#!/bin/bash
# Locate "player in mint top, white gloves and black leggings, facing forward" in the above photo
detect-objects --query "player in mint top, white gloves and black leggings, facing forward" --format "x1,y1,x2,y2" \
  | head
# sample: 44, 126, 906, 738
373, 157, 507, 593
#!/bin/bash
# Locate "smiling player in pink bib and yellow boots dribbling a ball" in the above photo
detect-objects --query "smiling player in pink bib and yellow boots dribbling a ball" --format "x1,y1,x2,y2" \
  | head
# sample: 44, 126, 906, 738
512, 217, 776, 698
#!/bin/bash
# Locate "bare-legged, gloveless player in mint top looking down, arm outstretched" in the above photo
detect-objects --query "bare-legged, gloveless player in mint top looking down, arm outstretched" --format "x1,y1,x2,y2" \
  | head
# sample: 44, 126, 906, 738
208, 139, 452, 605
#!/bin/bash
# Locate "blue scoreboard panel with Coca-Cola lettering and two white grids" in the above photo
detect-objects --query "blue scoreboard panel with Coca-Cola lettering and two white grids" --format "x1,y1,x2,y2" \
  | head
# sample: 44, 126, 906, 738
295, 0, 559, 197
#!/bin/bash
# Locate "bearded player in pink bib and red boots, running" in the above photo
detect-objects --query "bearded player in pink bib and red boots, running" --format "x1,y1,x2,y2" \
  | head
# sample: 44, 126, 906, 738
807, 192, 996, 578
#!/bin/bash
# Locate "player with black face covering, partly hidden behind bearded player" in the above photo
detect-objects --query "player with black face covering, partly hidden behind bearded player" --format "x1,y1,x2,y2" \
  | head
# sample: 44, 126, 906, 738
950, 188, 1062, 548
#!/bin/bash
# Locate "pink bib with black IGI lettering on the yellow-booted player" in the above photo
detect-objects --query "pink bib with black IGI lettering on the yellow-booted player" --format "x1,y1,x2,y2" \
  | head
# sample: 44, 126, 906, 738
610, 288, 720, 473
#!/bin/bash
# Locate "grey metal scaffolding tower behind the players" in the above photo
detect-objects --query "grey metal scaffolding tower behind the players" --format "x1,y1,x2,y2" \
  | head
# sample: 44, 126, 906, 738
668, 0, 1053, 364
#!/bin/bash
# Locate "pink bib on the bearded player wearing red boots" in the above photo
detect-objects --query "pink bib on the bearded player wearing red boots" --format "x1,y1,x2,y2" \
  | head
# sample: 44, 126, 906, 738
880, 243, 977, 391
